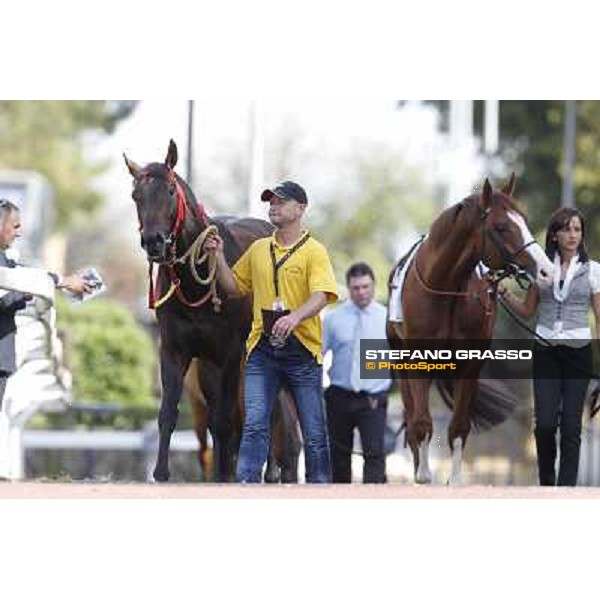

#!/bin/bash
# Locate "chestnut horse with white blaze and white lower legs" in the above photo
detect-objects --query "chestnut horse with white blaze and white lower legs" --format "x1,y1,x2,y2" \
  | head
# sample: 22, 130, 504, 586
387, 173, 553, 484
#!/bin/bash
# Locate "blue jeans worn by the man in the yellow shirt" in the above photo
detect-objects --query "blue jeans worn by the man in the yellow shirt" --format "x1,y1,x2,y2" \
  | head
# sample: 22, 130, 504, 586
236, 336, 331, 483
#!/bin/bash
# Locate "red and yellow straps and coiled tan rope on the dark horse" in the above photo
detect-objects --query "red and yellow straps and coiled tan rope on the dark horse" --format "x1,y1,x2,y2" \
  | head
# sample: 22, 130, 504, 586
148, 171, 221, 312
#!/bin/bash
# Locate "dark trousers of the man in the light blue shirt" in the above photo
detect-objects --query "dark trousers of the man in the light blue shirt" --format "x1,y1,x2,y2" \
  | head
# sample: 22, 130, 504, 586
325, 385, 387, 483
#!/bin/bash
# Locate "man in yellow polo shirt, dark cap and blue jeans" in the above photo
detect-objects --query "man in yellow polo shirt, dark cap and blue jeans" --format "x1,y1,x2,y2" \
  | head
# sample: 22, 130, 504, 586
204, 181, 337, 483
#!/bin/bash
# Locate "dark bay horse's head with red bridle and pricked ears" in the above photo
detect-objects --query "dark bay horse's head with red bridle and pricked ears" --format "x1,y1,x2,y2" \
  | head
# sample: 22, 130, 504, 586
123, 140, 202, 263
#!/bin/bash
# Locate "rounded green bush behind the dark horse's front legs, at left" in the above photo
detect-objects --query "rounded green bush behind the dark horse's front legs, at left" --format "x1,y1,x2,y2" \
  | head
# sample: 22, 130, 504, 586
57, 299, 156, 408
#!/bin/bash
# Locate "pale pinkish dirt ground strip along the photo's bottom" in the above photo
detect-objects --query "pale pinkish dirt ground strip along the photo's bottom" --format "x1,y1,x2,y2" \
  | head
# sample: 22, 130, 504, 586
0, 481, 600, 500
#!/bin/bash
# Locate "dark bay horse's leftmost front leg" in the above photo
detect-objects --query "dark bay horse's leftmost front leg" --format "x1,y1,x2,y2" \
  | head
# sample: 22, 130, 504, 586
154, 346, 191, 481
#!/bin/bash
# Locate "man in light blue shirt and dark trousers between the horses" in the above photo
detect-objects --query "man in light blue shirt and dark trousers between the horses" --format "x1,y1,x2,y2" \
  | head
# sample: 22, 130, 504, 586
323, 263, 391, 483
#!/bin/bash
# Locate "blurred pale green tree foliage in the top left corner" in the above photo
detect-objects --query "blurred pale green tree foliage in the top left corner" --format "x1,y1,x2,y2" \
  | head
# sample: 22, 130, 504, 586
0, 100, 135, 230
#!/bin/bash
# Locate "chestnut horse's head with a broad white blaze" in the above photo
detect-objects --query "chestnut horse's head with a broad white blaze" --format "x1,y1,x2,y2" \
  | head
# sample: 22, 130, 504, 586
478, 173, 554, 287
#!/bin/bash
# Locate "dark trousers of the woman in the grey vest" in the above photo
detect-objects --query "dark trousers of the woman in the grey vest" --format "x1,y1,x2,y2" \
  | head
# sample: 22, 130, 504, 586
533, 344, 592, 485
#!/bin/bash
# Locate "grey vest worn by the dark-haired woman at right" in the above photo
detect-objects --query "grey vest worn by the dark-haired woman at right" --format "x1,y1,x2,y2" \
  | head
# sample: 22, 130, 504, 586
538, 262, 592, 331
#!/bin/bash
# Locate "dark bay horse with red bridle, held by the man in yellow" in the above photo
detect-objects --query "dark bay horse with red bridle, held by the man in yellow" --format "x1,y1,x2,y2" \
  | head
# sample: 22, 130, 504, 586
124, 140, 299, 481
